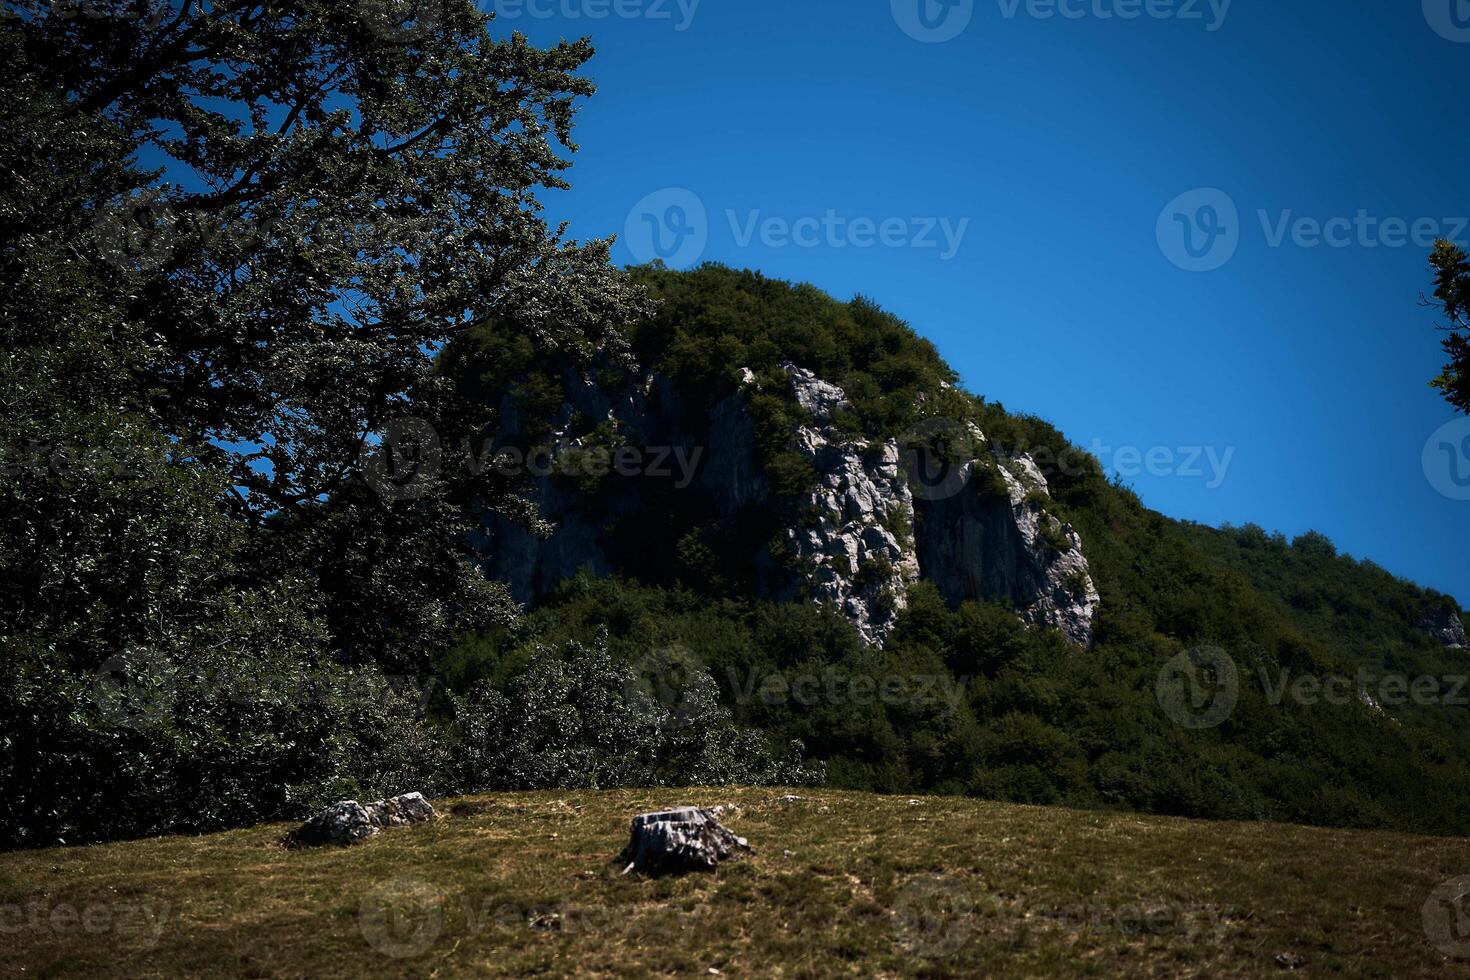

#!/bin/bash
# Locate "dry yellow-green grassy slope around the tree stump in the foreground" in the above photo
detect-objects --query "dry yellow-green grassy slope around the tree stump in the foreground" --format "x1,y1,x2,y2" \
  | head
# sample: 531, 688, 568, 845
0, 789, 1470, 977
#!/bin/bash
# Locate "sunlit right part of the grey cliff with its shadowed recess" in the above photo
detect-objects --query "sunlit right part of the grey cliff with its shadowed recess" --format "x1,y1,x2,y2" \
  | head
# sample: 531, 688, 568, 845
786, 364, 1098, 646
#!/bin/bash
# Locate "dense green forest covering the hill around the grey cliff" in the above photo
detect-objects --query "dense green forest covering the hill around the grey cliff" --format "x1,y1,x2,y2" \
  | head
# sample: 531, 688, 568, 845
444, 266, 1470, 832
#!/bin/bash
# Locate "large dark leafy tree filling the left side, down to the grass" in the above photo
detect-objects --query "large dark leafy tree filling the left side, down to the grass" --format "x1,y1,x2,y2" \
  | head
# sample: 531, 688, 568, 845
0, 0, 642, 845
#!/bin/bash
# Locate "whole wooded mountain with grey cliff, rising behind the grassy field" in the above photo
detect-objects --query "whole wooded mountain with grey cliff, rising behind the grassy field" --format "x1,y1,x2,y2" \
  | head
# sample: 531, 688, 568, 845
444, 266, 1470, 833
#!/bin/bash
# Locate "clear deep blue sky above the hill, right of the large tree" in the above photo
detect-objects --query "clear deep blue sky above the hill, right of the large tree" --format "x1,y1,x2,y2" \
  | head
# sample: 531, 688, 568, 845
508, 0, 1470, 602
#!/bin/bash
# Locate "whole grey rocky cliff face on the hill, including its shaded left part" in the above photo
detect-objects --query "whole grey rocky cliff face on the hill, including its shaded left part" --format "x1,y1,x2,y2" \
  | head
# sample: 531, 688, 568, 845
482, 364, 1098, 646
